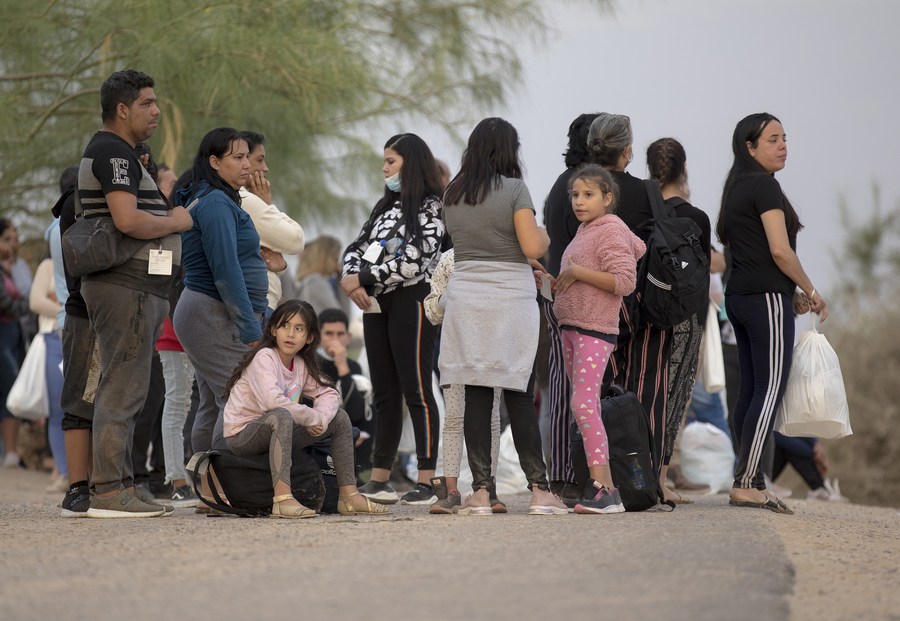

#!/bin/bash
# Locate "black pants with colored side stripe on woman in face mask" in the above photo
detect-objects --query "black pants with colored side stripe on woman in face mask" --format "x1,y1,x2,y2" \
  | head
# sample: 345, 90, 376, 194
363, 283, 440, 470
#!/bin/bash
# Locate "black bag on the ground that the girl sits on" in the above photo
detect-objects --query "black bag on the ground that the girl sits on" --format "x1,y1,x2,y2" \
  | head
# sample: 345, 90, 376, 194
187, 448, 325, 517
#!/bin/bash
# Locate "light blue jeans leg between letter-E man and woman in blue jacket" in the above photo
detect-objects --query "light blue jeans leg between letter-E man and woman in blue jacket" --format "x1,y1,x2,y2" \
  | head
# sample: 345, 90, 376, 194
159, 351, 194, 483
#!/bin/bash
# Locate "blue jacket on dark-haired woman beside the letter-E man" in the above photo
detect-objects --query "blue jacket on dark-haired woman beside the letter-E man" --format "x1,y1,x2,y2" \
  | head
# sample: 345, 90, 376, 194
178, 182, 269, 343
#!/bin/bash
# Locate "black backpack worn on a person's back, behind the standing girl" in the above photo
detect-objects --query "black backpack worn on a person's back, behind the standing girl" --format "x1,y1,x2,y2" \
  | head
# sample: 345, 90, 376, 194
636, 179, 709, 328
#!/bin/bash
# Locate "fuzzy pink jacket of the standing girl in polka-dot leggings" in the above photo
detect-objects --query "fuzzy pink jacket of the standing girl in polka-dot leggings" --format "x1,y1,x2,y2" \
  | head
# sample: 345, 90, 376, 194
553, 214, 646, 334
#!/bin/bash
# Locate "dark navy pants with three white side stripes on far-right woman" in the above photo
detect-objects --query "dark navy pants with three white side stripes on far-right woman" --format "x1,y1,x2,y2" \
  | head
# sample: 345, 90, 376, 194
725, 293, 794, 489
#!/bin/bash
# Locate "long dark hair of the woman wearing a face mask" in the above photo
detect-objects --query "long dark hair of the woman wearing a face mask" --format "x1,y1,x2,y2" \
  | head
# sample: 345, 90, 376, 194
363, 134, 442, 245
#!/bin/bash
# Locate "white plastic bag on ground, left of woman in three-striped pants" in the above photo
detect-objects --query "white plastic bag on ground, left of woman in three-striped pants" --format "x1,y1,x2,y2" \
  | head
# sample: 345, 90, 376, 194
681, 421, 734, 494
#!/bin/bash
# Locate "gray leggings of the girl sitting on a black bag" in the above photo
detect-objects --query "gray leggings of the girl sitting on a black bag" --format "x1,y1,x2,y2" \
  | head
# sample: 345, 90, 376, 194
225, 408, 356, 487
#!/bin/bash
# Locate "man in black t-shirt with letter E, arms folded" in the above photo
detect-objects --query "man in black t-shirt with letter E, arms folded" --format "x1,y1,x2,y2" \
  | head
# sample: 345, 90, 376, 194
75, 70, 192, 518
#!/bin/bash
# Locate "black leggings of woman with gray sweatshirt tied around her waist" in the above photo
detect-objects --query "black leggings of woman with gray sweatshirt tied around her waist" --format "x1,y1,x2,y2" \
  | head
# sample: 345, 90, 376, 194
465, 373, 549, 490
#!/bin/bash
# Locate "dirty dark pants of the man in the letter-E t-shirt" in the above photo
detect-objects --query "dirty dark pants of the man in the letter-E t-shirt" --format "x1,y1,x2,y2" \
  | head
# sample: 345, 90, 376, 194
81, 280, 169, 493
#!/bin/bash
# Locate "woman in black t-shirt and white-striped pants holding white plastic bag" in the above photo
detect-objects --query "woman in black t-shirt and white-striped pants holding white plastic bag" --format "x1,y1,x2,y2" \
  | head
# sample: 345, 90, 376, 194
716, 113, 828, 513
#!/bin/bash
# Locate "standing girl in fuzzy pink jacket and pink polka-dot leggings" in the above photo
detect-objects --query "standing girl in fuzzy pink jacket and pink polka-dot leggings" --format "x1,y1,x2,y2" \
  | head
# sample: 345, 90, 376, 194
553, 165, 646, 513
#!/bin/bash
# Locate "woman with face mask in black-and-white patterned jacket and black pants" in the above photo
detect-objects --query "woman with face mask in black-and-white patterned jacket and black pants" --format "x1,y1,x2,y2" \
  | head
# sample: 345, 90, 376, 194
341, 134, 444, 505
